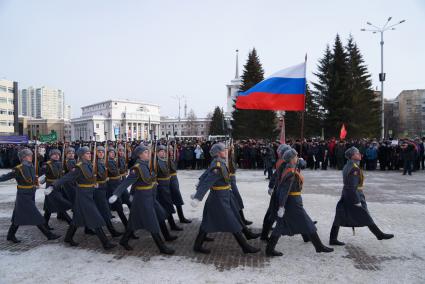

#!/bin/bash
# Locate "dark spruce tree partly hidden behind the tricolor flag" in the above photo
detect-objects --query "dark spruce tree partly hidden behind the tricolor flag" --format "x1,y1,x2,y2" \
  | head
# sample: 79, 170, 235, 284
232, 48, 277, 139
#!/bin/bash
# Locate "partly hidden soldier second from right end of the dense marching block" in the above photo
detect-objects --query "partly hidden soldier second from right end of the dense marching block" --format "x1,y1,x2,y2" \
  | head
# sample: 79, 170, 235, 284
156, 145, 183, 231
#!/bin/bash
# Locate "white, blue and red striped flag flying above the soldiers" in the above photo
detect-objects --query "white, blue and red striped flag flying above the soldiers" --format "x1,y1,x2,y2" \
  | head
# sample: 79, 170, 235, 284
236, 62, 306, 111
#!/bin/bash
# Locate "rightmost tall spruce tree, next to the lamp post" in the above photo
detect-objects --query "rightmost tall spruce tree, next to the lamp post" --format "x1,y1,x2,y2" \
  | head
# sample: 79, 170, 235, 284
346, 35, 380, 138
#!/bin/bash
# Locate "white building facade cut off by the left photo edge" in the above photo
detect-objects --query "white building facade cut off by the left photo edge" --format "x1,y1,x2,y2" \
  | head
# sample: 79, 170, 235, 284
0, 79, 15, 135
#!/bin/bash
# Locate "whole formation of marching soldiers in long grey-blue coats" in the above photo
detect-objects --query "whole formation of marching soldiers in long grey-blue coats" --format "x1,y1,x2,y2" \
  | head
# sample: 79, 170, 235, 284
0, 139, 394, 257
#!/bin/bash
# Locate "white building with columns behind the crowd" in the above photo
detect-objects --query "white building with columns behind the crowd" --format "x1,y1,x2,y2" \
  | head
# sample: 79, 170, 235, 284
71, 100, 160, 141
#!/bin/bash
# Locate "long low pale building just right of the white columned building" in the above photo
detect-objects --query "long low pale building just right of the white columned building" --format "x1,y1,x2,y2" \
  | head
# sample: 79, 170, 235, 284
159, 117, 211, 138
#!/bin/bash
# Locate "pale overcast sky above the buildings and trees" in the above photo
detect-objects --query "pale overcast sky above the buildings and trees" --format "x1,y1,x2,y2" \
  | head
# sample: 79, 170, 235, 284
0, 0, 425, 117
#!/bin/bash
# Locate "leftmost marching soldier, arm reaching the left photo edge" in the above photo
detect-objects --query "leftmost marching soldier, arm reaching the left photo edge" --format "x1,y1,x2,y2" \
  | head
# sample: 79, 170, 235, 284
0, 148, 60, 243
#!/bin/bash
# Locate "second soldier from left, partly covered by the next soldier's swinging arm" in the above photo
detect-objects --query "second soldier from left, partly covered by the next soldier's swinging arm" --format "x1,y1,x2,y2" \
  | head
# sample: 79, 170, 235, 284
43, 149, 72, 230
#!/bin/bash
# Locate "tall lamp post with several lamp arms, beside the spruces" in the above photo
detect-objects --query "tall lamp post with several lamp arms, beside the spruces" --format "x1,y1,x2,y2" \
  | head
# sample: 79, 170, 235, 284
361, 17, 406, 139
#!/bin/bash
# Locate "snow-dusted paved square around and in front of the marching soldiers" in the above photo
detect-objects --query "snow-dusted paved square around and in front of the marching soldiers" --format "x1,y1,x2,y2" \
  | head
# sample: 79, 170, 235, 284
0, 170, 425, 283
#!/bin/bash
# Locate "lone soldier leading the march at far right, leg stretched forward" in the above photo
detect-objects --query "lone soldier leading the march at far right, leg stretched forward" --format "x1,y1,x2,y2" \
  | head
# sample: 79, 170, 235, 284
329, 147, 394, 246
